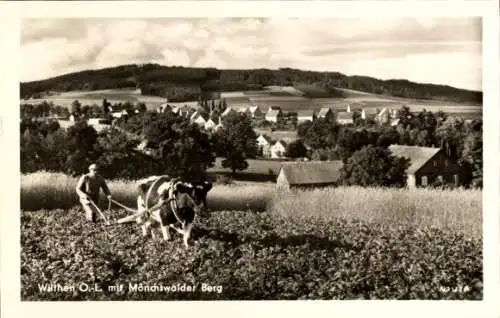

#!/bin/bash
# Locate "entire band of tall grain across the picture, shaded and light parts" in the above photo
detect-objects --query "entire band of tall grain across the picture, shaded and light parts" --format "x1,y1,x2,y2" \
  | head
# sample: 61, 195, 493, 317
21, 172, 482, 237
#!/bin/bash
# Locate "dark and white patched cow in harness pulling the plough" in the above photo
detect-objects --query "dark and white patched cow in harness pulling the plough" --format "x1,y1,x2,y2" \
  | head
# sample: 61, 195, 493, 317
136, 176, 212, 247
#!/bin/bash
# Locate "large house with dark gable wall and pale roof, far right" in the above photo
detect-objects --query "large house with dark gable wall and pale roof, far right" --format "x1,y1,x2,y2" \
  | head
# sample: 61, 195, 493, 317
389, 145, 464, 188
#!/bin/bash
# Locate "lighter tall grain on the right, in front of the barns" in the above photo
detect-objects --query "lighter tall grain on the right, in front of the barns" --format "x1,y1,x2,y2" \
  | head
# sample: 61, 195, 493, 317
269, 187, 482, 237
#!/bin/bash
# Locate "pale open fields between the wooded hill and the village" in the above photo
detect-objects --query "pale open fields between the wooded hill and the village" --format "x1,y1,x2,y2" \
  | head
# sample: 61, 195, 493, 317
23, 86, 482, 118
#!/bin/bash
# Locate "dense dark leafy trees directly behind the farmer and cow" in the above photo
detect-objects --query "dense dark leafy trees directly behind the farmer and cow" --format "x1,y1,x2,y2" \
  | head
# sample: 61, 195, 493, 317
20, 111, 257, 180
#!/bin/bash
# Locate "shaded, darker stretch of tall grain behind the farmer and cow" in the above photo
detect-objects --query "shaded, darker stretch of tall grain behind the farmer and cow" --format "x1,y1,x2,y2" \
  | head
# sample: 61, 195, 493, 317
21, 172, 274, 211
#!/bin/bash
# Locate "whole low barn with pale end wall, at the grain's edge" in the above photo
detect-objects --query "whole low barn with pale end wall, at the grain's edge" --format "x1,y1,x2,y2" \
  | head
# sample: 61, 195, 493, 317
276, 160, 343, 190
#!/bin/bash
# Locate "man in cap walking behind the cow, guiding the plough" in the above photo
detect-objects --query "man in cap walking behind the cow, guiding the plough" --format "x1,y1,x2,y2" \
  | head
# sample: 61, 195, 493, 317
76, 164, 111, 222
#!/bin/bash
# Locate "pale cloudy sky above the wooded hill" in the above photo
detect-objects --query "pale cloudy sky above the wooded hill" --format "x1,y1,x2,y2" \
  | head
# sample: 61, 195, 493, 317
21, 17, 482, 90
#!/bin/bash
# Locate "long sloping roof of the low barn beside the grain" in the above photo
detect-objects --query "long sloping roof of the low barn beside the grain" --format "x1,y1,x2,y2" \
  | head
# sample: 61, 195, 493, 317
280, 160, 343, 185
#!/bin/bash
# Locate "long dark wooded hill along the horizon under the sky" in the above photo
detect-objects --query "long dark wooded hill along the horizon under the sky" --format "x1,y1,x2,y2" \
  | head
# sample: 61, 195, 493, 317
21, 64, 483, 103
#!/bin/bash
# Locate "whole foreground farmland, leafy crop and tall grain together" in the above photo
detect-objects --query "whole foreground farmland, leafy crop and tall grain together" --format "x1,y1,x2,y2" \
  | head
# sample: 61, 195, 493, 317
21, 173, 483, 300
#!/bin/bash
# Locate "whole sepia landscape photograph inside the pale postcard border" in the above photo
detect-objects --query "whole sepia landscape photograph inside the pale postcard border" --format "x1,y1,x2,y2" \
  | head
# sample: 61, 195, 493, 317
2, 0, 499, 316
